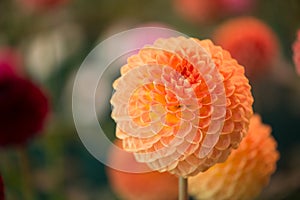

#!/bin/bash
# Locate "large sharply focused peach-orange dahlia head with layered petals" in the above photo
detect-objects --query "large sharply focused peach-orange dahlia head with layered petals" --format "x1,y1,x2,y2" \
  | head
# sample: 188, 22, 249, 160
111, 37, 253, 177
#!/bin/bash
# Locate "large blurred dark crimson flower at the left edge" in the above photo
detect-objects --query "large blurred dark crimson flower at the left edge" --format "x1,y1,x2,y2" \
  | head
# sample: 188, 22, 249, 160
0, 72, 49, 146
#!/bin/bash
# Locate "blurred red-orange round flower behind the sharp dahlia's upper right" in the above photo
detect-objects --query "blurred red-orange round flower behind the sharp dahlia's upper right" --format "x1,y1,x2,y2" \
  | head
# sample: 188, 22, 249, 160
214, 17, 279, 78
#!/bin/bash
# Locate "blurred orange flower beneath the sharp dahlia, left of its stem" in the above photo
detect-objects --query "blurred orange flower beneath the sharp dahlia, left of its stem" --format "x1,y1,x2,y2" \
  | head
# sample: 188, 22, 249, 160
107, 140, 178, 200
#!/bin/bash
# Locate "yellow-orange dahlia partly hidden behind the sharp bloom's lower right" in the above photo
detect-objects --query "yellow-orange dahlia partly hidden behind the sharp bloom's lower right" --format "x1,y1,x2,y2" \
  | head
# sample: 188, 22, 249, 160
188, 114, 279, 200
